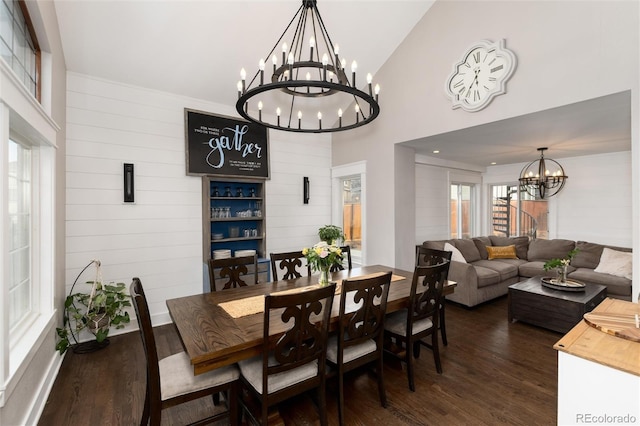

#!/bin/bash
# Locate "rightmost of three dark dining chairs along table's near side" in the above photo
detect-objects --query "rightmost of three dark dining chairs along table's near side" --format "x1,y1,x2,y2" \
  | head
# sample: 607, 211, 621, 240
384, 262, 449, 391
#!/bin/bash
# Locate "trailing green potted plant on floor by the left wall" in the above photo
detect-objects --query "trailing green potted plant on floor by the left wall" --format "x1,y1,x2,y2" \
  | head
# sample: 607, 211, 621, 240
56, 260, 131, 355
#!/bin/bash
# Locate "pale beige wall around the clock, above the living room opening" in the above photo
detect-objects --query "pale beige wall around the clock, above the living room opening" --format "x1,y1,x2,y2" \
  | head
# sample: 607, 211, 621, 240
332, 0, 640, 286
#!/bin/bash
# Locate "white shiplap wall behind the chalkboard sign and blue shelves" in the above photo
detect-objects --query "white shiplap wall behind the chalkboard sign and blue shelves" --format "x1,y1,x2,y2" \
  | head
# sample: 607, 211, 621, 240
65, 73, 331, 324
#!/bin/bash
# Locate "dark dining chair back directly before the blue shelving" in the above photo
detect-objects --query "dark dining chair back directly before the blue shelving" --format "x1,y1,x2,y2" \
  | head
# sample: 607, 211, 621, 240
209, 254, 258, 291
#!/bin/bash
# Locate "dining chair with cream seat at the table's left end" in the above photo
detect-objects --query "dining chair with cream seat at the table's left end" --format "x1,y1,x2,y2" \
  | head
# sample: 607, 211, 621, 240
129, 278, 240, 426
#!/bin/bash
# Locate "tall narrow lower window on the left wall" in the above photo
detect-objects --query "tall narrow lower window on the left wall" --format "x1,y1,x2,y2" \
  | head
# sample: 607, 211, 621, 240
7, 140, 32, 334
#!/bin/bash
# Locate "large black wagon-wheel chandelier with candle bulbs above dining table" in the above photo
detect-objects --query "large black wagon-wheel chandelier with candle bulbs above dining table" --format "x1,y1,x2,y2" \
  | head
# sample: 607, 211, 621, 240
236, 0, 380, 133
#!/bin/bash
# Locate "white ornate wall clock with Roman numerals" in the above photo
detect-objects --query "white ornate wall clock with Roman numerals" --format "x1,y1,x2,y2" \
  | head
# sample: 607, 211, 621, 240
446, 40, 516, 112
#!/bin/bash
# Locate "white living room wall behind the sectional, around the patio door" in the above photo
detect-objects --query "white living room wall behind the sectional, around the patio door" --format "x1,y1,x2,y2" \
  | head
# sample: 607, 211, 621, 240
483, 151, 633, 247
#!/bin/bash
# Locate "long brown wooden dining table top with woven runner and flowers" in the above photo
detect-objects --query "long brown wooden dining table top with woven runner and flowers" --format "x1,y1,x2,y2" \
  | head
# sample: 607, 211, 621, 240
167, 265, 456, 375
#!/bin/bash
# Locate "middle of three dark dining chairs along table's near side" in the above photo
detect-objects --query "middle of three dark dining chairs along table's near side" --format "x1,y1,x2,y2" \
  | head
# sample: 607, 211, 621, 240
327, 272, 391, 425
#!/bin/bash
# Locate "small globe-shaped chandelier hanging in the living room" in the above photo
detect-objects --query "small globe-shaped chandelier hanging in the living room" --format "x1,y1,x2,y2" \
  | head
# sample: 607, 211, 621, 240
518, 148, 569, 200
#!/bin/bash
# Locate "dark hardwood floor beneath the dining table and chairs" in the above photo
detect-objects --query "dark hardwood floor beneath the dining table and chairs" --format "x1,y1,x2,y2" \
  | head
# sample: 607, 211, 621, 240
39, 297, 561, 426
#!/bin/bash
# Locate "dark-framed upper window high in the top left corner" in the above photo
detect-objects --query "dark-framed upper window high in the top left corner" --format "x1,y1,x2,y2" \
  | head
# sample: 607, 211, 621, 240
0, 0, 40, 101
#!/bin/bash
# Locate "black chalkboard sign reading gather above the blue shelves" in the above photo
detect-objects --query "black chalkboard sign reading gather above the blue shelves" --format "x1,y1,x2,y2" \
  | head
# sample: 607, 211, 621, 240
184, 108, 269, 179
